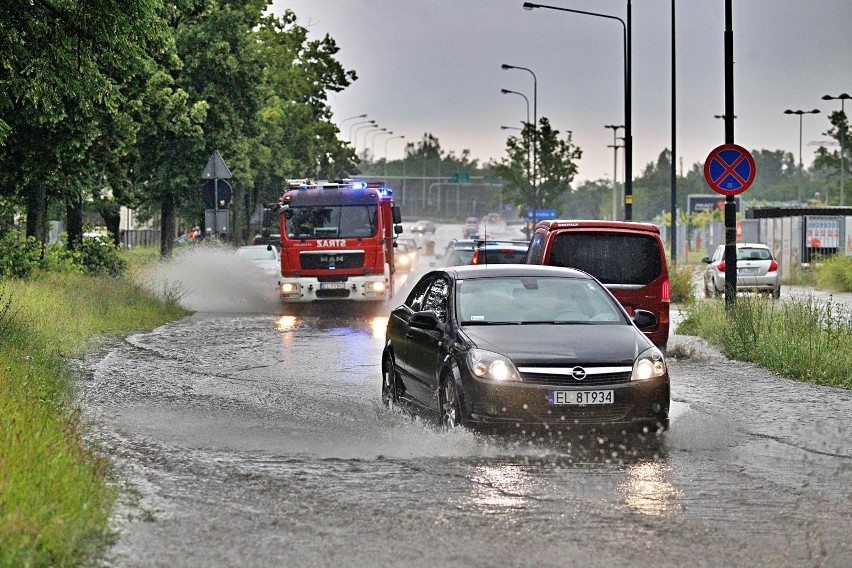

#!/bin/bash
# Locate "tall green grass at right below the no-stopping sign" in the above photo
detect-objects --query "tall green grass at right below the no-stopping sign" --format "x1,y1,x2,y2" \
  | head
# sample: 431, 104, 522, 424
678, 296, 852, 389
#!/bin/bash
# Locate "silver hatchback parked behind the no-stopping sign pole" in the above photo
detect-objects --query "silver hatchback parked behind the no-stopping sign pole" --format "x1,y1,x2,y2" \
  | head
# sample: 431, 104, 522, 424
702, 243, 781, 298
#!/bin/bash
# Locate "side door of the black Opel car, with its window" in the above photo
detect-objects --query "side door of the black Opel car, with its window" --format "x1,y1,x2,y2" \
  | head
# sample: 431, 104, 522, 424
405, 275, 450, 407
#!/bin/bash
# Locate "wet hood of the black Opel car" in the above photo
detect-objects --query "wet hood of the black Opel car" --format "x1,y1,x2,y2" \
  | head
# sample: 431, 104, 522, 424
464, 324, 652, 366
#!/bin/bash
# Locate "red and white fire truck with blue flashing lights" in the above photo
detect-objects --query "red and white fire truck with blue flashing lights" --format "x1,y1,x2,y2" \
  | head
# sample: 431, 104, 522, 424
263, 179, 402, 303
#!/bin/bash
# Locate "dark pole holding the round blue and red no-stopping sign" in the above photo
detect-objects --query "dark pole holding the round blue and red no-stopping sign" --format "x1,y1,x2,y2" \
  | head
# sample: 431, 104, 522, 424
725, 0, 737, 310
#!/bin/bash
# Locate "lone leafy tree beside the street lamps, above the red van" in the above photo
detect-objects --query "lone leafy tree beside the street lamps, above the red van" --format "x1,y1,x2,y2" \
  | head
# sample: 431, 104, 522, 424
491, 117, 583, 215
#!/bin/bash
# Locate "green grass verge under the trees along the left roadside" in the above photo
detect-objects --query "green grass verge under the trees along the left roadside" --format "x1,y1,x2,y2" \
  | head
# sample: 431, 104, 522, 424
0, 262, 187, 567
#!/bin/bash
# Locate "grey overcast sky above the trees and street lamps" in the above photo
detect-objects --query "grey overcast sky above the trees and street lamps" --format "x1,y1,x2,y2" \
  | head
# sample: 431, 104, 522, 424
273, 0, 852, 184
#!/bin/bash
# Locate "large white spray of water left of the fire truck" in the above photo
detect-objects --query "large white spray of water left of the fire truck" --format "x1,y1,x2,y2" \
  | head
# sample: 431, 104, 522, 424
138, 243, 281, 313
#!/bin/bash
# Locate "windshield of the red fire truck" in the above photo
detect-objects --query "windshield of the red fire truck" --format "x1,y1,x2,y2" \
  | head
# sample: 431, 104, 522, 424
284, 205, 378, 239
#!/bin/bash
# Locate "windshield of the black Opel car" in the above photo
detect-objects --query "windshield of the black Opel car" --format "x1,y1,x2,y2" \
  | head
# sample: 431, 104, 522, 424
456, 276, 626, 325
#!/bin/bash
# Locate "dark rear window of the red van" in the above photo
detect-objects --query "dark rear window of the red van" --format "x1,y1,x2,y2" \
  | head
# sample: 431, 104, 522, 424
548, 231, 663, 286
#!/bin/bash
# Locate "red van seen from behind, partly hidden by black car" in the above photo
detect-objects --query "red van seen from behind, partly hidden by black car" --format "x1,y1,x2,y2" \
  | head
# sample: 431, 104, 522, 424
526, 220, 671, 353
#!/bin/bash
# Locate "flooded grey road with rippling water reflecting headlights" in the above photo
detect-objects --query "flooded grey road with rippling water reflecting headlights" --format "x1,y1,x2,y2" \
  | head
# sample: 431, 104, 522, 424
79, 232, 852, 568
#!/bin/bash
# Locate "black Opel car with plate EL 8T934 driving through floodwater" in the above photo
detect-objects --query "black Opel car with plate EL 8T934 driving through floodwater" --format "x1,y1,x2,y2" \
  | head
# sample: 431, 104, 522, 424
382, 264, 669, 431
